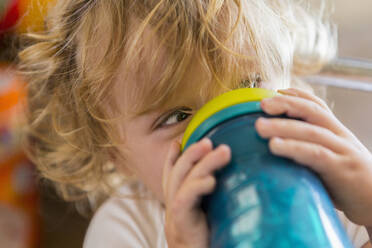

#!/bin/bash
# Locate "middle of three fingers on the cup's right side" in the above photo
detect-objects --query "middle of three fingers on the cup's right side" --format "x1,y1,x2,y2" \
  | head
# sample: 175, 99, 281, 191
255, 117, 350, 154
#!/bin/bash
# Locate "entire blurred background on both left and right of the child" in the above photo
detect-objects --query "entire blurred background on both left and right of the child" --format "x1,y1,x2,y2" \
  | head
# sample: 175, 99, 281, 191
0, 0, 372, 248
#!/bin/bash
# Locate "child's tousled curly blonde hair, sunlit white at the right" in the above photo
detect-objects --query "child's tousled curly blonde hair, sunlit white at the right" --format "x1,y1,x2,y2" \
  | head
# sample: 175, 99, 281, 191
19, 0, 336, 213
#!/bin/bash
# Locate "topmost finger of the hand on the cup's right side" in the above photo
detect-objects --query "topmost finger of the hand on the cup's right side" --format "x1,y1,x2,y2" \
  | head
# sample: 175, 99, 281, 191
261, 95, 345, 136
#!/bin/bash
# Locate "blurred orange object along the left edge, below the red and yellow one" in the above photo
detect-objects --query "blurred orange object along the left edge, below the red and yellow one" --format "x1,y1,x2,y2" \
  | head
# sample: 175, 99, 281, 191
0, 65, 40, 248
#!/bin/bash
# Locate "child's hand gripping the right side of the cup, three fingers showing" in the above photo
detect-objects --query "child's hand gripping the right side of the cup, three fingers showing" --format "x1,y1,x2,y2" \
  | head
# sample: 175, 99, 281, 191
256, 89, 372, 226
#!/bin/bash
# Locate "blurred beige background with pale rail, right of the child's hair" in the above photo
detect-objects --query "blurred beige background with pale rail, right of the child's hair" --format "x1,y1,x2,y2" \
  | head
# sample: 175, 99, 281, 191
313, 0, 372, 151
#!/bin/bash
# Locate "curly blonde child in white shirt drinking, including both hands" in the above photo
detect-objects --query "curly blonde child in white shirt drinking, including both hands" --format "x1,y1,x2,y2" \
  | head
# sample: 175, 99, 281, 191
20, 0, 372, 248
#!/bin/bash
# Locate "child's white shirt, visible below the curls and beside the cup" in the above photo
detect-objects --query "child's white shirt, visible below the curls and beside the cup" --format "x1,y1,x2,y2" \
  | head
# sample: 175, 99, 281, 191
83, 186, 369, 248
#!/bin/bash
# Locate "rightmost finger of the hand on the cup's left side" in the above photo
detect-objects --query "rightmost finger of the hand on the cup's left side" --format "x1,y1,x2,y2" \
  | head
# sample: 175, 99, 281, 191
186, 145, 231, 180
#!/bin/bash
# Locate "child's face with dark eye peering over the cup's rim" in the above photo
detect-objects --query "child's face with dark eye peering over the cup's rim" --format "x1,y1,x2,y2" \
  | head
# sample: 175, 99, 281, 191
114, 51, 208, 202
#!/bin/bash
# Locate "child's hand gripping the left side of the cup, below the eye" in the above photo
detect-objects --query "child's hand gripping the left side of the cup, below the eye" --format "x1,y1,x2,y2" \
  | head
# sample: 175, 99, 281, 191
163, 139, 231, 248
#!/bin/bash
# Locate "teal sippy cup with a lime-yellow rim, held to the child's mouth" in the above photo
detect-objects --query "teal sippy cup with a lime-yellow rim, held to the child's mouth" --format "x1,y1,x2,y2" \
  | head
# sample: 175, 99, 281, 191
182, 88, 352, 248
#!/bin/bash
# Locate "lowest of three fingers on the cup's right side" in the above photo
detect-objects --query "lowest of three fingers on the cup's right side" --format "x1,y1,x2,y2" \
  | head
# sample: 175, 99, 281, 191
269, 137, 341, 177
